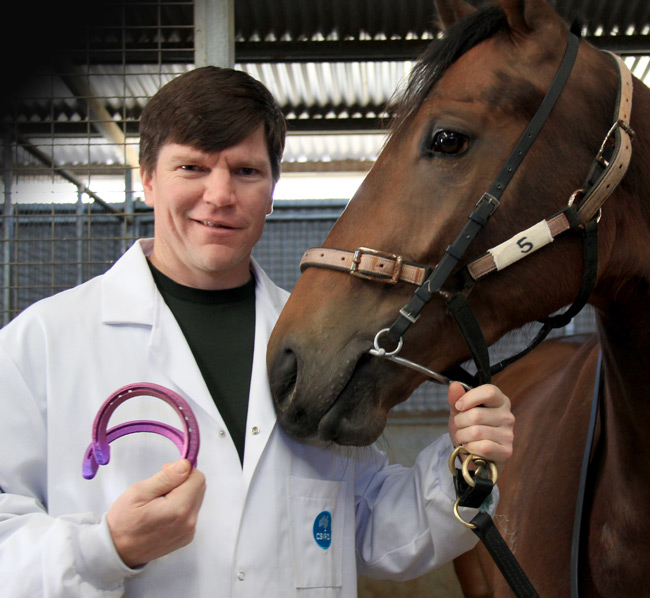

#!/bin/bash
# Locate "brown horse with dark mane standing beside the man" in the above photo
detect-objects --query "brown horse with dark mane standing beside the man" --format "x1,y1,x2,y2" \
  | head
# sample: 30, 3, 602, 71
268, 0, 650, 598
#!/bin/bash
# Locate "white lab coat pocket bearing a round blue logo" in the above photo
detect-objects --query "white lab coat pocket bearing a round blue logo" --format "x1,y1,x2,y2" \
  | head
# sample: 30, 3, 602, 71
288, 477, 345, 588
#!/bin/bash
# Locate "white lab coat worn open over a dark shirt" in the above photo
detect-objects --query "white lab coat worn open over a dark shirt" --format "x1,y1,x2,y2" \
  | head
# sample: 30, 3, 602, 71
0, 240, 484, 598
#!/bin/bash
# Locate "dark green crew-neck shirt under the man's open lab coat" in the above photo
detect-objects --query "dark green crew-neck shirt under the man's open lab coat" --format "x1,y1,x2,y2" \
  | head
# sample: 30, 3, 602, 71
149, 262, 255, 462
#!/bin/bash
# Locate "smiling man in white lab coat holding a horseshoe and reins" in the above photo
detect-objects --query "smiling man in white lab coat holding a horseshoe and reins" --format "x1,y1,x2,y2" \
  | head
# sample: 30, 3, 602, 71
0, 67, 513, 598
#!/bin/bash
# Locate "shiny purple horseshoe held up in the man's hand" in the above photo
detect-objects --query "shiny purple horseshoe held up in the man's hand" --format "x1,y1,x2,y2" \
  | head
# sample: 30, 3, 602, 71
82, 382, 199, 480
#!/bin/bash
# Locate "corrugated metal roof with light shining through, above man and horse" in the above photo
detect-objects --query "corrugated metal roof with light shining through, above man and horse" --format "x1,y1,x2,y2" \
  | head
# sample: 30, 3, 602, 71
4, 0, 650, 178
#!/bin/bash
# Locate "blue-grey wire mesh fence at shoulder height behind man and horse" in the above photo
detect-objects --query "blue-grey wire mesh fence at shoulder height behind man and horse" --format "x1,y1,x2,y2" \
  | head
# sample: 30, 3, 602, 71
0, 201, 594, 415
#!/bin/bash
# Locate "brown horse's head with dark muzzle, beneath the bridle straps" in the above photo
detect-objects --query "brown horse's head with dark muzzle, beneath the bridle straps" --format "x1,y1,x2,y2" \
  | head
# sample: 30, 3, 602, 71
267, 0, 636, 445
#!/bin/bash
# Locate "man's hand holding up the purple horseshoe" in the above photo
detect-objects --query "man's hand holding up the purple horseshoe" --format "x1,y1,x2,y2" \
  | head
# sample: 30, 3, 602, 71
106, 459, 205, 567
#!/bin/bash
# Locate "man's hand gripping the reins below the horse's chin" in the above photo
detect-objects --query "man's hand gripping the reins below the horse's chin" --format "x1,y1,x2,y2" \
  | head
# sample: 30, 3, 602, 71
447, 382, 515, 471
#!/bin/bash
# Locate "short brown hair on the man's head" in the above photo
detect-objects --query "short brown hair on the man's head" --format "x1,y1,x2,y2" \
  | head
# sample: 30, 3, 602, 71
140, 66, 286, 182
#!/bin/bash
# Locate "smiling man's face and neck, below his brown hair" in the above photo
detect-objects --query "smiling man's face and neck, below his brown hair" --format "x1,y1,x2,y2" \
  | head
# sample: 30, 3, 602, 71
141, 126, 274, 289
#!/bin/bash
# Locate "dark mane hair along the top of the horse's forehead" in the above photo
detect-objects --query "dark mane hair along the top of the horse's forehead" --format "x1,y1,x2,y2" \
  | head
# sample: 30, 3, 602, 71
392, 6, 508, 133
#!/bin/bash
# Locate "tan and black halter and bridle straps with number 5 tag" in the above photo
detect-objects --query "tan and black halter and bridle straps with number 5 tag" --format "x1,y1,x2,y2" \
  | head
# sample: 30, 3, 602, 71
300, 33, 634, 388
